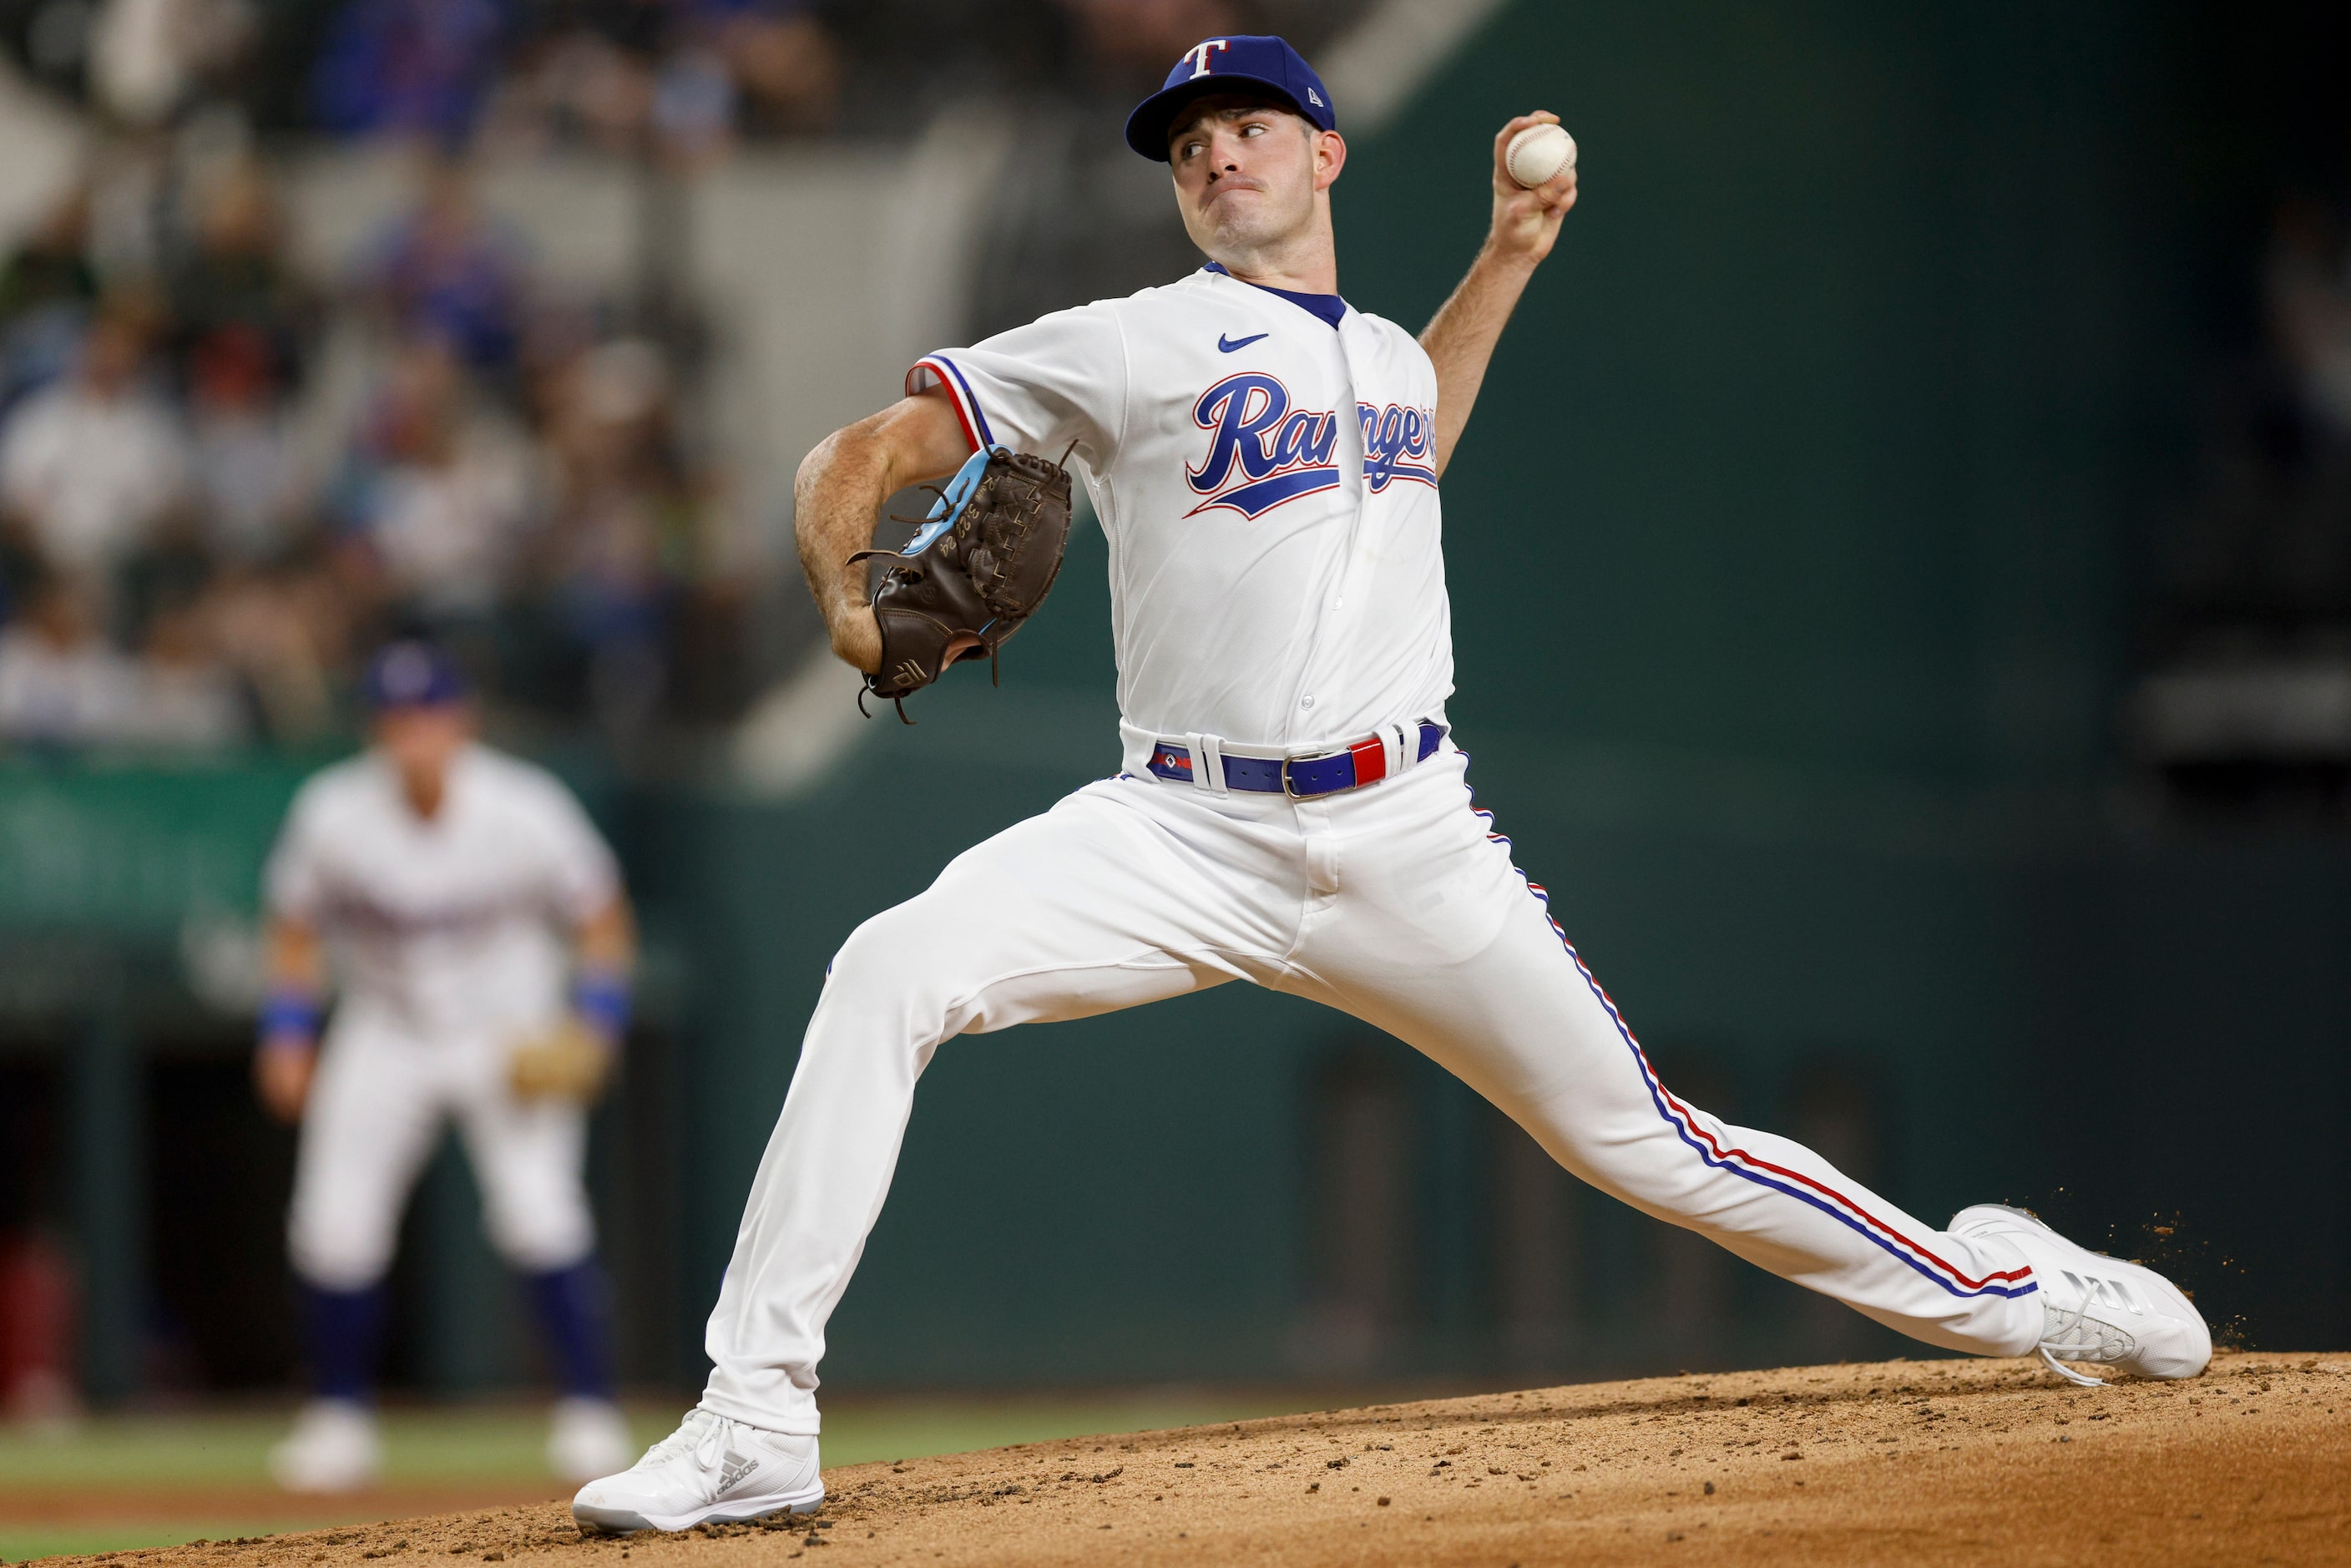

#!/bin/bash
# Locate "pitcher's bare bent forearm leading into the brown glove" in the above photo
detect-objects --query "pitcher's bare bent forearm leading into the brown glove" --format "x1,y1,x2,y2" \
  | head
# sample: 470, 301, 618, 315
792, 386, 971, 675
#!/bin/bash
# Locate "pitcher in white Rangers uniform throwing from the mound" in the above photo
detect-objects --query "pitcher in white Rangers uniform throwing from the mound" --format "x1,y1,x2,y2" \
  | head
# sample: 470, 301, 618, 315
574, 38, 2210, 1530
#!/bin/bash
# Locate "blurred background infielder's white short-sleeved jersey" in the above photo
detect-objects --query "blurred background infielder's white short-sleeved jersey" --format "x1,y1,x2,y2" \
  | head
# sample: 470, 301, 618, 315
268, 746, 620, 1039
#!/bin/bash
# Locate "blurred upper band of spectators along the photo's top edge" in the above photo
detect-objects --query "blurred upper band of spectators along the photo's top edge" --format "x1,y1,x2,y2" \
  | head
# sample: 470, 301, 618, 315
0, 0, 1361, 153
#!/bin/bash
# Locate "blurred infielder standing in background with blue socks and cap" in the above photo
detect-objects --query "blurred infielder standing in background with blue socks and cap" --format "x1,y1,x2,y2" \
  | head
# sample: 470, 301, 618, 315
254, 642, 635, 1490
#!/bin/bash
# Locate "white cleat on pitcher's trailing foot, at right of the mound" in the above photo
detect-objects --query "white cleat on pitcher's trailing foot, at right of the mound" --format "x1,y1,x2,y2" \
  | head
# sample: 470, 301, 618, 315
1951, 1204, 2212, 1387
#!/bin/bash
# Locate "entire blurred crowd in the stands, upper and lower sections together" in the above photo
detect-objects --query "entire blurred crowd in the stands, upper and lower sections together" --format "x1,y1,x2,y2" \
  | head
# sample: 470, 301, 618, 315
0, 0, 1361, 750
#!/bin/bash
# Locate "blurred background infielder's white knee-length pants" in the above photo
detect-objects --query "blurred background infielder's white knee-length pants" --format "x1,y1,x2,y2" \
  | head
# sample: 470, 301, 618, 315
287, 1006, 594, 1291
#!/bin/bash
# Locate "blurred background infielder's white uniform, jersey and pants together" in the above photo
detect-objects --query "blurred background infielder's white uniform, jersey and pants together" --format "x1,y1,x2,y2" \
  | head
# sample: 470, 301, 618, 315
268, 746, 620, 1291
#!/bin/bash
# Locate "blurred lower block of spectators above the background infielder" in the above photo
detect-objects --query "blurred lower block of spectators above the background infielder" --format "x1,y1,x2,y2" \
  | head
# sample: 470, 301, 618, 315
0, 153, 747, 747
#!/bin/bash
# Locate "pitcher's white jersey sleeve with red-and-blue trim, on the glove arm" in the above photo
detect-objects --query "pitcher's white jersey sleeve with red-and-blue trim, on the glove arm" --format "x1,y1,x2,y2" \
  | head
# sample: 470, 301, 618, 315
905, 303, 1126, 470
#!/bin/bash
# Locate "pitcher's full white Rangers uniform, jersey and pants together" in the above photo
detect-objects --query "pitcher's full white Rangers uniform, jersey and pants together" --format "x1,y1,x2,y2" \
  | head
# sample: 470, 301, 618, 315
703, 268, 2043, 1434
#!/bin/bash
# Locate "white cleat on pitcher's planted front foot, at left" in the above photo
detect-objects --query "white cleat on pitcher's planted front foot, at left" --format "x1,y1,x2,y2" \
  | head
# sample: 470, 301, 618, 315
571, 1410, 825, 1535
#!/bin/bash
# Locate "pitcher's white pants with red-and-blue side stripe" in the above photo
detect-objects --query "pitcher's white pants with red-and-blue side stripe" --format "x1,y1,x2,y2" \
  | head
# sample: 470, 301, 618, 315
703, 746, 2040, 1434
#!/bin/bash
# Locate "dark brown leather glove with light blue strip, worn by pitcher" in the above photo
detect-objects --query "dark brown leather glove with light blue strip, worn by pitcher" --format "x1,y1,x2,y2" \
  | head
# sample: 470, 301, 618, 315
849, 434, 1069, 724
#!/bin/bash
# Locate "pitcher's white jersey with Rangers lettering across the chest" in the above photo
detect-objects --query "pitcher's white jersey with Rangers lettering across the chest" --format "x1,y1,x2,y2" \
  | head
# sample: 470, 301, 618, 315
908, 268, 1453, 769
